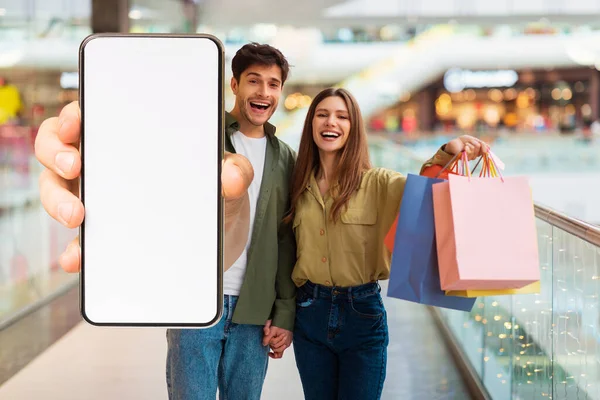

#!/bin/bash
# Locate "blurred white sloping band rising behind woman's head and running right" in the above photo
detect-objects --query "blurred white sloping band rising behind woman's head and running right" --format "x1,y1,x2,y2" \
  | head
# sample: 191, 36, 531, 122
273, 25, 600, 148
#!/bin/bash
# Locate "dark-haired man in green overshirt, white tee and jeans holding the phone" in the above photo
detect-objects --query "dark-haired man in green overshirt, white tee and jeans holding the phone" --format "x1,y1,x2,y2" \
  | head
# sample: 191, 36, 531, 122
36, 43, 296, 400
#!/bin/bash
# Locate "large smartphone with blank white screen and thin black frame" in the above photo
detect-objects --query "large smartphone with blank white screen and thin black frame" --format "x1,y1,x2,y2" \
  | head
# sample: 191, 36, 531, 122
79, 34, 224, 328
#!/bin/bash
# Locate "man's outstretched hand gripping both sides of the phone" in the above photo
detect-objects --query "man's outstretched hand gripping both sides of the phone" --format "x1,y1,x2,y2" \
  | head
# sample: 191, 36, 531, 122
35, 102, 254, 272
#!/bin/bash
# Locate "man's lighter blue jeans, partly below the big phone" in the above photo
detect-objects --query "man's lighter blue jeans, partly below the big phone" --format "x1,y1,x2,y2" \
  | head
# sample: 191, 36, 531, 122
167, 296, 269, 400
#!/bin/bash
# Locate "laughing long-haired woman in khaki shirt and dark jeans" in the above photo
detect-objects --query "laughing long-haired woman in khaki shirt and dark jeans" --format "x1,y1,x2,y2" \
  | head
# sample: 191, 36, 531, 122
286, 89, 482, 400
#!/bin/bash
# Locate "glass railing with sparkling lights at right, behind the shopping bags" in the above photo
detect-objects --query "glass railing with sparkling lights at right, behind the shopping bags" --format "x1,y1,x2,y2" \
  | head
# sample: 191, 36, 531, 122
371, 141, 600, 400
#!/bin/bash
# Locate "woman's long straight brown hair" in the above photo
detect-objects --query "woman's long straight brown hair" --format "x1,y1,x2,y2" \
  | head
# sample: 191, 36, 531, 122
284, 88, 371, 223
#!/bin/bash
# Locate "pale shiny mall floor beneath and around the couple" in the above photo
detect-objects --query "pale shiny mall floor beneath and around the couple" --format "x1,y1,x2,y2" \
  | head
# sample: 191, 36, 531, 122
0, 285, 470, 400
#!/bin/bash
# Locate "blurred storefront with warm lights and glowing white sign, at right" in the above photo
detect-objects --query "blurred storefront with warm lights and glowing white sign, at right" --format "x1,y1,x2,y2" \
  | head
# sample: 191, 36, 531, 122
370, 68, 600, 135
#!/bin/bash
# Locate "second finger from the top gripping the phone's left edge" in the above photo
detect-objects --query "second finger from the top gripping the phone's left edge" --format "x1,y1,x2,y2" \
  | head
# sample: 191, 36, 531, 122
35, 114, 81, 179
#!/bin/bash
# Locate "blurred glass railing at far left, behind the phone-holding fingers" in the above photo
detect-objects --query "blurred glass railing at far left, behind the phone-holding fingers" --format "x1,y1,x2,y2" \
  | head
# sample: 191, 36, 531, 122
0, 125, 78, 329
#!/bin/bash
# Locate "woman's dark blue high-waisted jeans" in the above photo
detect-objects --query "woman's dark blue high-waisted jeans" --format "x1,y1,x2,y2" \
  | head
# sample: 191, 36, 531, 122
294, 282, 389, 400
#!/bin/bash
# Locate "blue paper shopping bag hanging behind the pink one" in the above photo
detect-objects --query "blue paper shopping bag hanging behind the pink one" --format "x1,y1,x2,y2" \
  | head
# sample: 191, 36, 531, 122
388, 174, 477, 311
